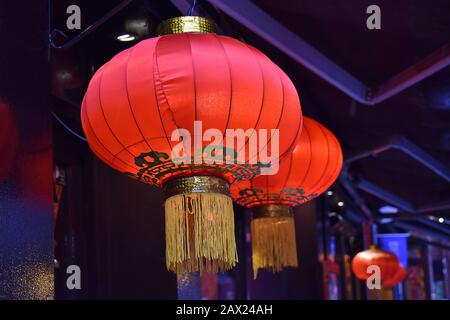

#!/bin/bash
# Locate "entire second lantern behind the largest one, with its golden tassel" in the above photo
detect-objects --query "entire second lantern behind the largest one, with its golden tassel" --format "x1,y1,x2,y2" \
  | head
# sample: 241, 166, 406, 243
231, 117, 342, 276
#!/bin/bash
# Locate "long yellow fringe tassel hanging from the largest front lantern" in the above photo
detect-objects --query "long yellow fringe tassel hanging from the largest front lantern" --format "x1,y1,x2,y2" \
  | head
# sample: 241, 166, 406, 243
165, 192, 238, 273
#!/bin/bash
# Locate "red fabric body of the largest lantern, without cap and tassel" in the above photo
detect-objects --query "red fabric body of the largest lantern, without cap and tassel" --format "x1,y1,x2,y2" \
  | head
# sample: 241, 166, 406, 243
81, 28, 302, 186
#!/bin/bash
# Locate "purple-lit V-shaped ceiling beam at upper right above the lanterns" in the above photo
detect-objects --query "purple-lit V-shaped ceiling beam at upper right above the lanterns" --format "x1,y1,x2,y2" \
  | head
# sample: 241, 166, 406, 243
175, 0, 450, 106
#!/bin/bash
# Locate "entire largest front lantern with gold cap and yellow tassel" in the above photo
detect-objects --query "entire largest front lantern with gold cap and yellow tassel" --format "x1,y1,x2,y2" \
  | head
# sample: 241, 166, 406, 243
81, 17, 302, 272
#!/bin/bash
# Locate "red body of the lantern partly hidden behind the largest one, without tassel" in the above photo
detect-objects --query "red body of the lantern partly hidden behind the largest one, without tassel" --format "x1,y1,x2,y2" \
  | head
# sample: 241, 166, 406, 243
231, 117, 342, 208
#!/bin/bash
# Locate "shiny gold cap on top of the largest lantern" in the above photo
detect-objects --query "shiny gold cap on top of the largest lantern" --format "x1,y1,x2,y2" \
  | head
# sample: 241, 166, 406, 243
156, 16, 217, 36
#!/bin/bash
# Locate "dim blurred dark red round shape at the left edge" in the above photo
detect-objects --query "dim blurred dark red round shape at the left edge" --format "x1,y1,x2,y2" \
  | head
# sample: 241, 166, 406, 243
0, 97, 19, 182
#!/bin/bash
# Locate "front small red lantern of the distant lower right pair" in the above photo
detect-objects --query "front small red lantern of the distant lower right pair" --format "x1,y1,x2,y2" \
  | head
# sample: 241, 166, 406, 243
352, 247, 400, 283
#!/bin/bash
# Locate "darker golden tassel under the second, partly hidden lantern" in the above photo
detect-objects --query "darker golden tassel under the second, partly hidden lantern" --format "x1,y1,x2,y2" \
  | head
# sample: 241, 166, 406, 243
251, 217, 298, 279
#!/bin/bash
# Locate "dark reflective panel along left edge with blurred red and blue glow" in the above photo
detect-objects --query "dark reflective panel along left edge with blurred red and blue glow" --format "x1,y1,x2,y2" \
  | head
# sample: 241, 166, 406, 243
0, 1, 53, 300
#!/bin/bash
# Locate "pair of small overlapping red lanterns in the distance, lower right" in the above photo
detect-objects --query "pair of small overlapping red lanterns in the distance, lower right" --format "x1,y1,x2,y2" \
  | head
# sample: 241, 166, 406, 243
352, 246, 408, 289
